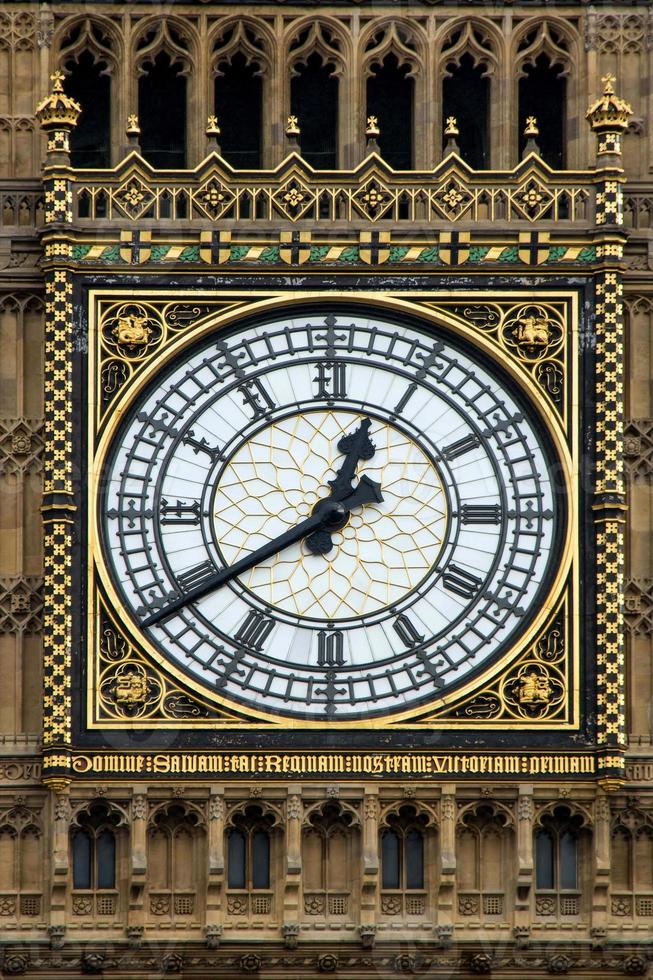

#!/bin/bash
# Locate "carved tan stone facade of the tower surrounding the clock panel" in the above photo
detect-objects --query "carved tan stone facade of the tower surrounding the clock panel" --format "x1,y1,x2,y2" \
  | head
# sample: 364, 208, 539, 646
0, 0, 653, 980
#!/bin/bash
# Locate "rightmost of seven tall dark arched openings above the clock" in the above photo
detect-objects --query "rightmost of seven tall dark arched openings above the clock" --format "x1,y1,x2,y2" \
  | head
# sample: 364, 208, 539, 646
519, 54, 567, 168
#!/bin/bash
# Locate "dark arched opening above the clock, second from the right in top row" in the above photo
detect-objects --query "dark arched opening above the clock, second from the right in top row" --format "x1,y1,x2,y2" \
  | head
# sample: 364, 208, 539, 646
442, 54, 490, 170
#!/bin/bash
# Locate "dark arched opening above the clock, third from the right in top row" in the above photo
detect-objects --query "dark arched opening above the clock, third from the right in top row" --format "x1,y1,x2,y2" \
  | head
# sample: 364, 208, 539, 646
367, 54, 414, 170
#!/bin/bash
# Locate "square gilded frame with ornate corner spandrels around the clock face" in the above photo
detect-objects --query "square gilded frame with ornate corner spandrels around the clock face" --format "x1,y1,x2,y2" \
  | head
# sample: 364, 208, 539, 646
84, 286, 580, 732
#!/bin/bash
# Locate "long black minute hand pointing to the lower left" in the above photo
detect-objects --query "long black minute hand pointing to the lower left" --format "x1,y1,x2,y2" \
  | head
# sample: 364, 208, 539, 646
141, 476, 383, 626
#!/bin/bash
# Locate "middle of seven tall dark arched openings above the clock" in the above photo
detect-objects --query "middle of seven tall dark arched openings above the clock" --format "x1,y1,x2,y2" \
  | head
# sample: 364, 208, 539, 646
290, 54, 338, 170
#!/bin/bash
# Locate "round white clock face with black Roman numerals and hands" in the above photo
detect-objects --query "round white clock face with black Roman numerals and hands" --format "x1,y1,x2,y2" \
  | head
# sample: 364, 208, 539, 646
98, 311, 566, 723
